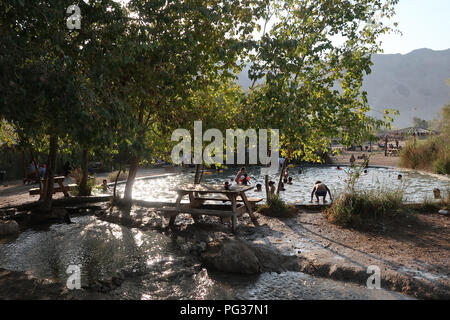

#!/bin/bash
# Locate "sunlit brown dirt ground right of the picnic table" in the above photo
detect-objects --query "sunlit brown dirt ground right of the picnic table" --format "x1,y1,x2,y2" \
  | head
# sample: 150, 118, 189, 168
245, 212, 450, 299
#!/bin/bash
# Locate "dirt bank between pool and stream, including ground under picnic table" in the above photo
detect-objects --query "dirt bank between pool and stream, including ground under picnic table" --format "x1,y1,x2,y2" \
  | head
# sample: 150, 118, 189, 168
93, 202, 450, 299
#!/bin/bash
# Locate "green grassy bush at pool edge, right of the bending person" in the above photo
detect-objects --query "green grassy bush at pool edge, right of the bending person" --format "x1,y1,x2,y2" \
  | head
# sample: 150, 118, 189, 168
325, 190, 404, 227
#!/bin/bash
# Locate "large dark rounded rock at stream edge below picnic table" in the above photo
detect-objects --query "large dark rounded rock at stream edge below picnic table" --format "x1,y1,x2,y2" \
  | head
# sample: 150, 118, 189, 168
202, 240, 261, 274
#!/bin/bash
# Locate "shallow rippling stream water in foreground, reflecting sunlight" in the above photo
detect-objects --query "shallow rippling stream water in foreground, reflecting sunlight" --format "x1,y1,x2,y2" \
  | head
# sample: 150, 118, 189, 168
0, 216, 414, 299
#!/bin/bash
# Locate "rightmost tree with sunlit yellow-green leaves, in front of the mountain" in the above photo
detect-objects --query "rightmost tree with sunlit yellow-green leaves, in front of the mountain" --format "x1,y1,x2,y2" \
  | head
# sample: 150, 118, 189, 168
244, 0, 397, 198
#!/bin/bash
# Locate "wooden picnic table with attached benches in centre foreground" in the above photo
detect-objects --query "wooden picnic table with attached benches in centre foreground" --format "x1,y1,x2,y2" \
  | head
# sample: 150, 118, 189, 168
158, 184, 257, 233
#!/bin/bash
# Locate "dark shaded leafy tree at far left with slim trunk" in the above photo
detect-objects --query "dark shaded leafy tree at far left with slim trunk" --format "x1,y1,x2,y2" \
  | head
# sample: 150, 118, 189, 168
0, 0, 123, 211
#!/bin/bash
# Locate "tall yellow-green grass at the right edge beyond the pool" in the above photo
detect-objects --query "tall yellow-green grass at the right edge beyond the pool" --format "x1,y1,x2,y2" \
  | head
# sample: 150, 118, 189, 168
400, 136, 450, 174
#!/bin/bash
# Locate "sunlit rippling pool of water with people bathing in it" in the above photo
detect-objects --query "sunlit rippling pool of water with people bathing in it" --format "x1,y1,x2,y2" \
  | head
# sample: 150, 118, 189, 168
110, 167, 450, 203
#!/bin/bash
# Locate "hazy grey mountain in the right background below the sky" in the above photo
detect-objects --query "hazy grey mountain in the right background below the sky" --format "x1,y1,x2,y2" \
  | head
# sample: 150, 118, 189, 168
238, 49, 450, 128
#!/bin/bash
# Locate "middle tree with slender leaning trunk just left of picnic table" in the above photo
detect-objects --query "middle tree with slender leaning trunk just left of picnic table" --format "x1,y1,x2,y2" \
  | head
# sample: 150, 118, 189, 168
118, 0, 267, 201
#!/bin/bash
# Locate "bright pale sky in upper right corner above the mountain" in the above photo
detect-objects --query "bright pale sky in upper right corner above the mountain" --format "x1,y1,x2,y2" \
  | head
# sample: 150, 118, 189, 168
380, 0, 450, 54
